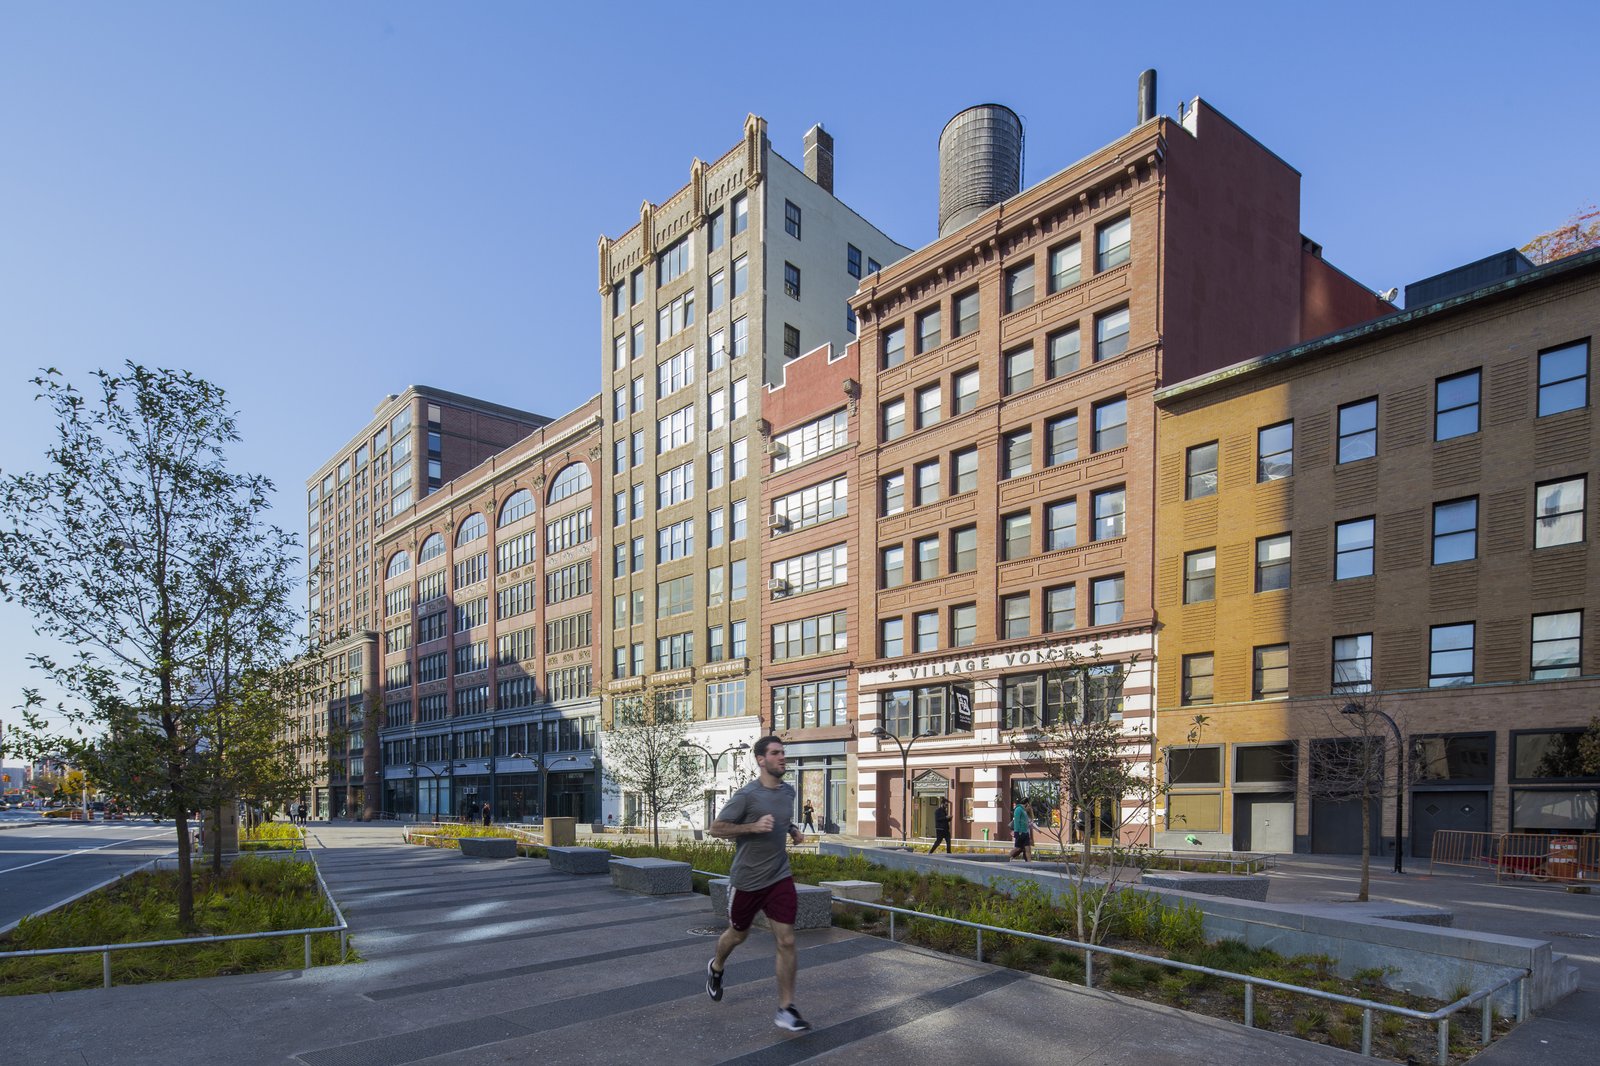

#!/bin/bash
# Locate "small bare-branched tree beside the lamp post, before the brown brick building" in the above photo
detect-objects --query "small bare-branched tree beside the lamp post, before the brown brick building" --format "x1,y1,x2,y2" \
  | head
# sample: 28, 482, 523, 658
1307, 693, 1405, 903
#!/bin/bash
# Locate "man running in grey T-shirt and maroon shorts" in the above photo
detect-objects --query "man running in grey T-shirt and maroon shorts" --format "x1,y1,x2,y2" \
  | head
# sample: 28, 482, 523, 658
706, 736, 811, 1032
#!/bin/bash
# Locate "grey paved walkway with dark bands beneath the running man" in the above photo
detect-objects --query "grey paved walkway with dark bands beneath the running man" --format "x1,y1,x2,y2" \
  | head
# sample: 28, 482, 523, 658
0, 824, 1360, 1066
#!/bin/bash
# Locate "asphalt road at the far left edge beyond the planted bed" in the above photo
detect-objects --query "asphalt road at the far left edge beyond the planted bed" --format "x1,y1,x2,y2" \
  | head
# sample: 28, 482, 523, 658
0, 812, 176, 928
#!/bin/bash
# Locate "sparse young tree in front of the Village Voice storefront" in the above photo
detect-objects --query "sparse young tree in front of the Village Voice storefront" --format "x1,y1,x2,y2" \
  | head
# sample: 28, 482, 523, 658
1005, 645, 1160, 943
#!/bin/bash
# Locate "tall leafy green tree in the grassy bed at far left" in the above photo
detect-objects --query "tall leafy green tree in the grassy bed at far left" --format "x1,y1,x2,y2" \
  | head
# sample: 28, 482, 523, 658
0, 363, 297, 927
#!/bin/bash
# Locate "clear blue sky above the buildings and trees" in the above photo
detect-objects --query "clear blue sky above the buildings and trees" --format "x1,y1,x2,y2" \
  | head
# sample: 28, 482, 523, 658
0, 0, 1600, 729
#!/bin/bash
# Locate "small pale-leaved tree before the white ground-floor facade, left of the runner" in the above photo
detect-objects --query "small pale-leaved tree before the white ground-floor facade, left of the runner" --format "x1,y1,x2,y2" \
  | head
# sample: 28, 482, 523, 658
602, 688, 706, 847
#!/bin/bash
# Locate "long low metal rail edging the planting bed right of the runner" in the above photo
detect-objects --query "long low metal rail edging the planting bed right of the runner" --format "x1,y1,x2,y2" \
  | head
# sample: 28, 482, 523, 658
678, 869, 1533, 1066
